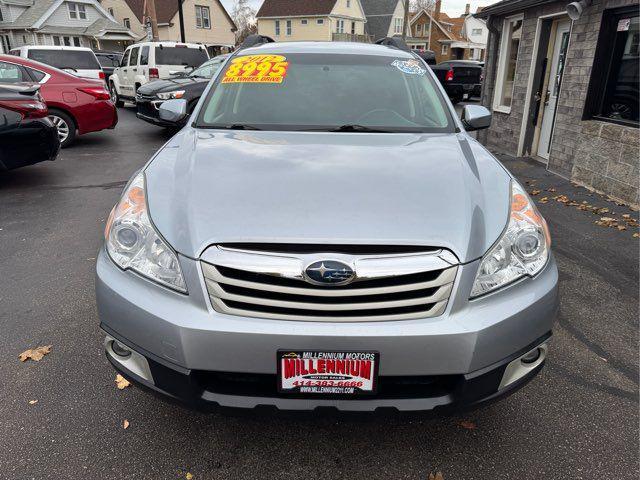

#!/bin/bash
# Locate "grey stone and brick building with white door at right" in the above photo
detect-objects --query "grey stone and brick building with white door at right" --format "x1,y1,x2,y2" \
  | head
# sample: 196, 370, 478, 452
477, 0, 640, 205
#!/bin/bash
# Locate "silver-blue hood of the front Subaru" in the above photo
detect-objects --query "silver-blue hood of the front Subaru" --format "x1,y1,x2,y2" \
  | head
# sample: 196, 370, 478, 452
145, 128, 511, 262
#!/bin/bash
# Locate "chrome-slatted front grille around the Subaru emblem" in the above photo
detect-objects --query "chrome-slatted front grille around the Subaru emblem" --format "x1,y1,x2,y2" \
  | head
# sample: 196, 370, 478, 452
202, 246, 457, 322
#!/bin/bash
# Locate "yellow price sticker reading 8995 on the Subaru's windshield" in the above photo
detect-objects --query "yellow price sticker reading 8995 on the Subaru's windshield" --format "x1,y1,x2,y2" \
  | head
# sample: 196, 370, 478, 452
222, 55, 289, 83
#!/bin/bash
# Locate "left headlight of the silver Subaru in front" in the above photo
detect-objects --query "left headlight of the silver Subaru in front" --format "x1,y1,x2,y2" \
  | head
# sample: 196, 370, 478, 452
104, 172, 187, 293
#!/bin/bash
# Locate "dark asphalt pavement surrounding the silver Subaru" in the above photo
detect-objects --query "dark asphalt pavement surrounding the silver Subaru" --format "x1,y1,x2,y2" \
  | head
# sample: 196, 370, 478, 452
0, 109, 639, 480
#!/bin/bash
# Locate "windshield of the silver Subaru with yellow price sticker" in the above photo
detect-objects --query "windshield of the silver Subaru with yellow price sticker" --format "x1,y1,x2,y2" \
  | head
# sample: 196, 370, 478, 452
196, 53, 453, 132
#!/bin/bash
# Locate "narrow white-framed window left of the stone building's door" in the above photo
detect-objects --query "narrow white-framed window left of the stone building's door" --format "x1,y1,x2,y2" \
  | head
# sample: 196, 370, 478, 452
493, 16, 522, 113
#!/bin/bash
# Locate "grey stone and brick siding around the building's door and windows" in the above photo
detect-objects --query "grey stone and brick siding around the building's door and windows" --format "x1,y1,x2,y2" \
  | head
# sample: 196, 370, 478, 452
479, 0, 640, 205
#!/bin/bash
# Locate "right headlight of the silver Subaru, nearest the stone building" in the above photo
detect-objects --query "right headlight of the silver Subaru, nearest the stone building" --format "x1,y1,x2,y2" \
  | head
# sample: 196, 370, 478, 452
471, 181, 551, 298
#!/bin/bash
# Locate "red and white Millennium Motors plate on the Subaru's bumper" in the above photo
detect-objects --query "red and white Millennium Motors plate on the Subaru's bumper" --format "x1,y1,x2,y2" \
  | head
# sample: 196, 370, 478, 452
277, 350, 380, 396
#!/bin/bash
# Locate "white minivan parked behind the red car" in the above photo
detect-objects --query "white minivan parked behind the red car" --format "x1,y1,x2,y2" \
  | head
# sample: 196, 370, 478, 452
9, 45, 105, 80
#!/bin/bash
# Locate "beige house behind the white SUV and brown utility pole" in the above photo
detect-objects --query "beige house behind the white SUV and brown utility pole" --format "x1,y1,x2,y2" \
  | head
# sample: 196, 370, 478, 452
101, 0, 236, 53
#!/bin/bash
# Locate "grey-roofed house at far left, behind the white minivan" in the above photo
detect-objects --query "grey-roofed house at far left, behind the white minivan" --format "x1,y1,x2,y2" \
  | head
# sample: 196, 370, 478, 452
0, 0, 136, 52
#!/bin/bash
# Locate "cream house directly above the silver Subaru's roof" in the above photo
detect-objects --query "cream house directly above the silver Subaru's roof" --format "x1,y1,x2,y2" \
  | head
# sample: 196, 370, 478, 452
256, 0, 371, 42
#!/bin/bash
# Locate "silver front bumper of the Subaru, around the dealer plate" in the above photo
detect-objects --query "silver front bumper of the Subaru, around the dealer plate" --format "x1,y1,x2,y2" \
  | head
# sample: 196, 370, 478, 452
96, 249, 558, 411
